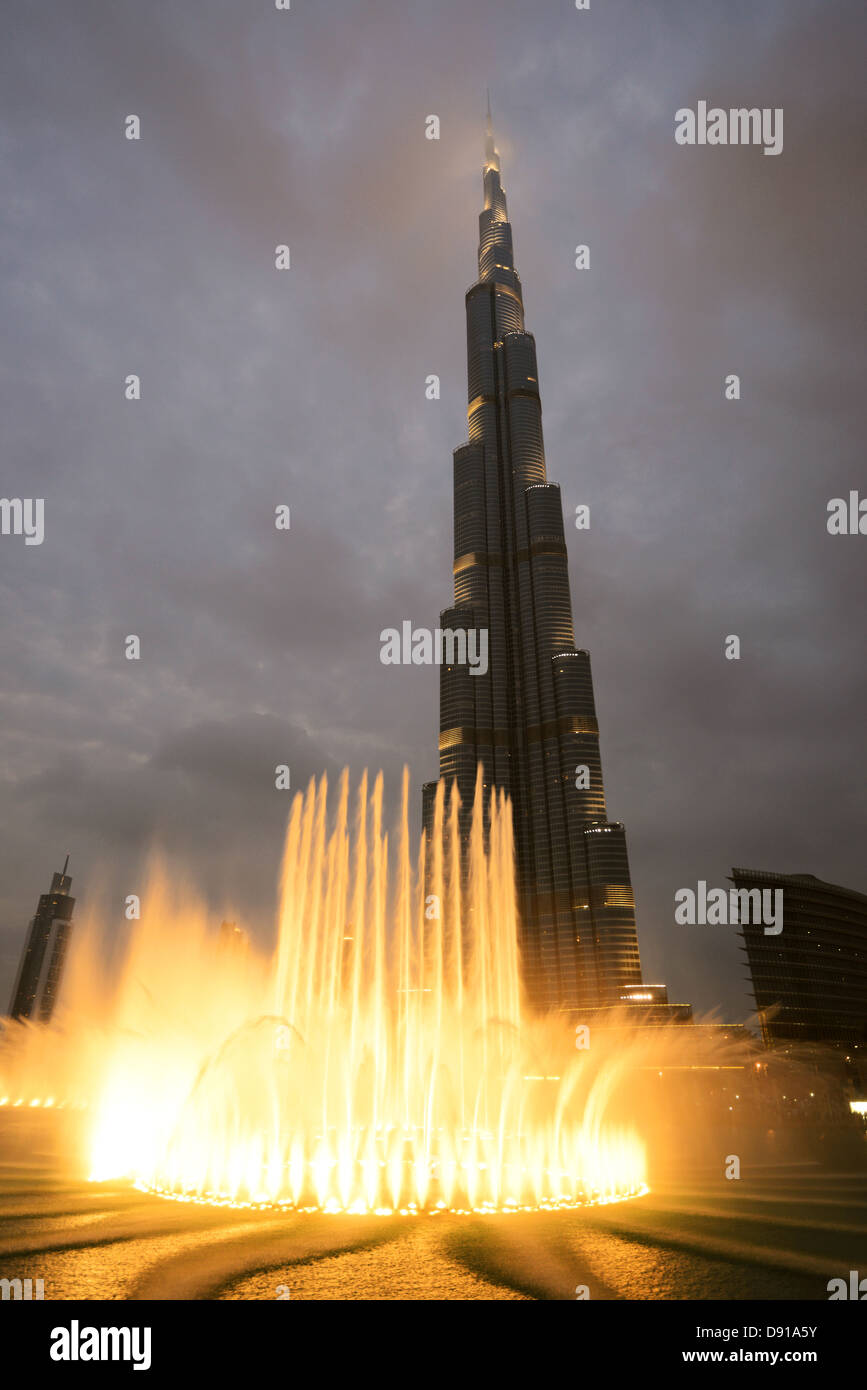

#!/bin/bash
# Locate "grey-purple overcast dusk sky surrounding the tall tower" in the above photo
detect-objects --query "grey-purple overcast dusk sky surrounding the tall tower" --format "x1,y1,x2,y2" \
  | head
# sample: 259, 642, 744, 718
0, 0, 867, 1019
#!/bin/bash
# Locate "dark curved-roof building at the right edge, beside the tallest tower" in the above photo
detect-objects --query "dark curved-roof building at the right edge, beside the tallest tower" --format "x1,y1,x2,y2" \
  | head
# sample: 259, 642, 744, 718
731, 869, 867, 1049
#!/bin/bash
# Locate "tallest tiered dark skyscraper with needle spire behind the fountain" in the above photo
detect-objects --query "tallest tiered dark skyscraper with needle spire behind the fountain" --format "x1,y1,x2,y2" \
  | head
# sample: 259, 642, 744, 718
424, 104, 642, 1008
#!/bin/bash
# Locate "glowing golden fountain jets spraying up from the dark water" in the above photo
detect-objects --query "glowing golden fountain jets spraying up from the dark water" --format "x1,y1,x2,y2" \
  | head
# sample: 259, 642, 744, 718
20, 771, 645, 1212
